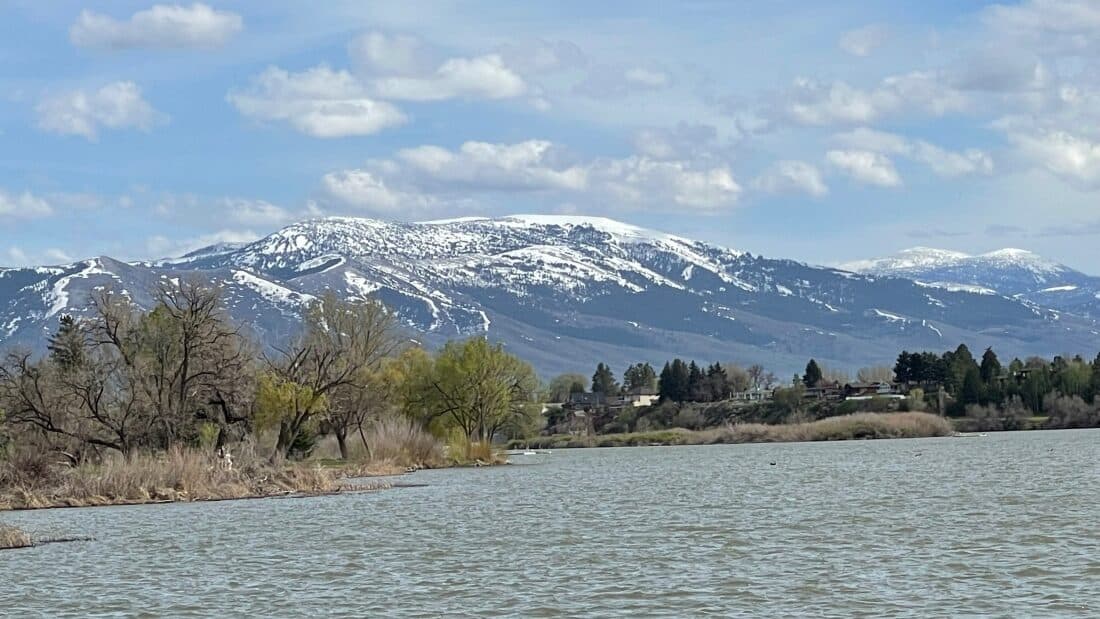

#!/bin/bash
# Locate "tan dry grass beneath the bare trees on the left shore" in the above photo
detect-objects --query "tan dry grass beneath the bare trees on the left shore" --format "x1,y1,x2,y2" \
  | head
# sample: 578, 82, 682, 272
0, 449, 387, 509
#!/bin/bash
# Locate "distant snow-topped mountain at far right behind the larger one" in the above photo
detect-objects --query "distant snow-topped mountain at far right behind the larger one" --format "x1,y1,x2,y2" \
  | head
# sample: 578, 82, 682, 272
842, 247, 1100, 317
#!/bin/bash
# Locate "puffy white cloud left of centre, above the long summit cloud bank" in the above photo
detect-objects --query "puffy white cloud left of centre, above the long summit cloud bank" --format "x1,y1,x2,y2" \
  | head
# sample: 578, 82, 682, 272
228, 65, 406, 137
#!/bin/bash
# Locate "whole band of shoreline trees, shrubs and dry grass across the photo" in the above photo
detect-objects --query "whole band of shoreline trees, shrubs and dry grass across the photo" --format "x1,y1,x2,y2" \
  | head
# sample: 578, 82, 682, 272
0, 280, 1100, 532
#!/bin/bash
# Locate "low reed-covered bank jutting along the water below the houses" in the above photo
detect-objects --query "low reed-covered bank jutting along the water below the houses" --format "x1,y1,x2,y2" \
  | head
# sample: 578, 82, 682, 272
509, 412, 955, 449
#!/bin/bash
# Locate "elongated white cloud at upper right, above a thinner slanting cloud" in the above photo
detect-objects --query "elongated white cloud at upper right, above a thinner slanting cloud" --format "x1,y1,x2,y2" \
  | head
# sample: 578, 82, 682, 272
782, 71, 968, 125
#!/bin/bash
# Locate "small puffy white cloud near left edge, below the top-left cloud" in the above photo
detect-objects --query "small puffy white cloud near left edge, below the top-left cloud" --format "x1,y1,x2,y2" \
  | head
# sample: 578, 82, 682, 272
35, 81, 161, 141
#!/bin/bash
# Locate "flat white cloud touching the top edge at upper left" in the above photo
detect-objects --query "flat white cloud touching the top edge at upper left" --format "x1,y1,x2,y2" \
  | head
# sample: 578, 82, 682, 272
69, 3, 244, 49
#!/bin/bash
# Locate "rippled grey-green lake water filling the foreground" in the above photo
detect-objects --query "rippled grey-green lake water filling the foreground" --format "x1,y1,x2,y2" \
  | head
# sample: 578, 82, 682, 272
0, 431, 1100, 617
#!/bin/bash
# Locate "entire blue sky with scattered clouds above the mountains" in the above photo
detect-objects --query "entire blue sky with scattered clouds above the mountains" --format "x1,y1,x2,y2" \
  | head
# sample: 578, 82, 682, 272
0, 0, 1100, 274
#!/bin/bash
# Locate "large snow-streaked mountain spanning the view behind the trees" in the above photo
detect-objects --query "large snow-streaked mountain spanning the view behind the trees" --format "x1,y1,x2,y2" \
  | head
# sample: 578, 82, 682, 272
0, 215, 1100, 374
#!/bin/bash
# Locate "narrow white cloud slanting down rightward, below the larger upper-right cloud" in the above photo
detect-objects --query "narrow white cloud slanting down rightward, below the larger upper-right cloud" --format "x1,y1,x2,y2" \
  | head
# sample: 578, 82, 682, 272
834, 128, 993, 177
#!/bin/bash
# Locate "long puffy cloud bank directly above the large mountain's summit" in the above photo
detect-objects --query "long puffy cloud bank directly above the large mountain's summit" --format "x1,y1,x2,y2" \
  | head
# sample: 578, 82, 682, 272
322, 140, 741, 214
